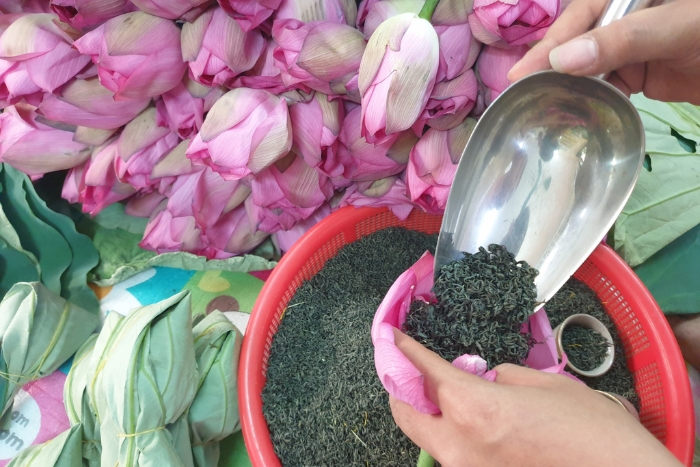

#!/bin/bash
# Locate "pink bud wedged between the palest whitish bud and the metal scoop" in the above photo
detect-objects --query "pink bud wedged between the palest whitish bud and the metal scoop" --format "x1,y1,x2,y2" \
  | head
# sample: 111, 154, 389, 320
420, 69, 479, 130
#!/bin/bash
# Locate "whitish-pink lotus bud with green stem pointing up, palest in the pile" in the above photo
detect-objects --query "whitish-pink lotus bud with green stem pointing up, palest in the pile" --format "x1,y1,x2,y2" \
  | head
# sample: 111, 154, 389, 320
358, 13, 440, 143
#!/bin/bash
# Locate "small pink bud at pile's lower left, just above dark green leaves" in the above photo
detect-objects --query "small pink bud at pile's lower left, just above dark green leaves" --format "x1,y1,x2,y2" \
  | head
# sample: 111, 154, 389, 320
63, 140, 136, 216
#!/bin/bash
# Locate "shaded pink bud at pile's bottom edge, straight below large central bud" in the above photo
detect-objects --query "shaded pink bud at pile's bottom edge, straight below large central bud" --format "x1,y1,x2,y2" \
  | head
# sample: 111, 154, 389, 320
205, 206, 269, 258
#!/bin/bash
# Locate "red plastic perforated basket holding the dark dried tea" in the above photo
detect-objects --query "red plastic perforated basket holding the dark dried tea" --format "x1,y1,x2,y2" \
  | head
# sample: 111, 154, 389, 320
238, 207, 695, 467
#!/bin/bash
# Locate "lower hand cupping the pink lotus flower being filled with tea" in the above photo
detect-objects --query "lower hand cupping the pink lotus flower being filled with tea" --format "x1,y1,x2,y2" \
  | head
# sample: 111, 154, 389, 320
390, 331, 681, 467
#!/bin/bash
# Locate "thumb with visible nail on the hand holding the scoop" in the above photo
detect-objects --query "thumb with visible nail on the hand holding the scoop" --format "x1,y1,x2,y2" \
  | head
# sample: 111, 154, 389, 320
549, 0, 700, 75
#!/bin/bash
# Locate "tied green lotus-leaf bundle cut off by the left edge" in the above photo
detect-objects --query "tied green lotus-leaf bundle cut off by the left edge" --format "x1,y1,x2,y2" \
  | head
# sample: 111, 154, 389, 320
0, 282, 99, 416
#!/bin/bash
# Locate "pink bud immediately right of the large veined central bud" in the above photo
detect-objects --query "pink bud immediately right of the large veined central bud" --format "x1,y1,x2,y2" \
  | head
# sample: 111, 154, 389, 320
289, 92, 344, 167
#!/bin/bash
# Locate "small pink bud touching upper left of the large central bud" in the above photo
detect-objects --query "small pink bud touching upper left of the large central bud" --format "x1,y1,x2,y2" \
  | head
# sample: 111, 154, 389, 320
156, 77, 226, 139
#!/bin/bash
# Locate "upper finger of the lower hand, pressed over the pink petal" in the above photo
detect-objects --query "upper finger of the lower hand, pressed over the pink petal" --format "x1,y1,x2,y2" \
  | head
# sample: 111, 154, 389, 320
394, 329, 487, 408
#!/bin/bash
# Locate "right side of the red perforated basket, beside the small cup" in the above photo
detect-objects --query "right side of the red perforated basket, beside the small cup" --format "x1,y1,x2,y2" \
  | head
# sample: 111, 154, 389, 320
575, 245, 695, 466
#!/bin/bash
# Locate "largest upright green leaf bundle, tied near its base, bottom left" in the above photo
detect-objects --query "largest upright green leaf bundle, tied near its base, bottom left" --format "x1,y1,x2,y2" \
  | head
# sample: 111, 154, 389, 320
88, 292, 198, 467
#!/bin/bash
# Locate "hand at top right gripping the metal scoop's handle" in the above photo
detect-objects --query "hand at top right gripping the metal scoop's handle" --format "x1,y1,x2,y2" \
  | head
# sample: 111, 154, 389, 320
508, 0, 700, 105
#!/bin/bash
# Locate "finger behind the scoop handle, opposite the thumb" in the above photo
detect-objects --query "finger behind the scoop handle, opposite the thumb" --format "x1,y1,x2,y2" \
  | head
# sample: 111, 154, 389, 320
508, 0, 606, 83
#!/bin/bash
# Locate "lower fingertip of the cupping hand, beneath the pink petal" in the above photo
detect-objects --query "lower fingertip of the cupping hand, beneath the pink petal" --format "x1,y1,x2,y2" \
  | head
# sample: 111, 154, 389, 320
389, 396, 442, 454
